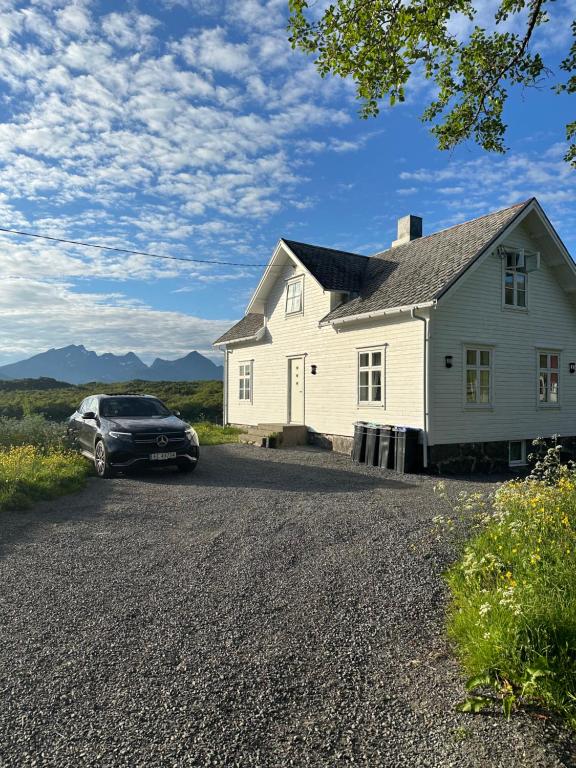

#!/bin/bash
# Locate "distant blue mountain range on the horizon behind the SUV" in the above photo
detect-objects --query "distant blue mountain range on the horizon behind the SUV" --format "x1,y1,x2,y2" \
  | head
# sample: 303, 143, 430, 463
0, 344, 222, 384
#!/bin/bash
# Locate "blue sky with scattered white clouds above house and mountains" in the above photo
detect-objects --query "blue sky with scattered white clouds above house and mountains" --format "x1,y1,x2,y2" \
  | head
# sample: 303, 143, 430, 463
0, 0, 576, 364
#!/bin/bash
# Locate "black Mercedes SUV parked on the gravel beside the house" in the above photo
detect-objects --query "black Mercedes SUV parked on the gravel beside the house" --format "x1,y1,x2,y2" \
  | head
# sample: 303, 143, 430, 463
68, 395, 200, 477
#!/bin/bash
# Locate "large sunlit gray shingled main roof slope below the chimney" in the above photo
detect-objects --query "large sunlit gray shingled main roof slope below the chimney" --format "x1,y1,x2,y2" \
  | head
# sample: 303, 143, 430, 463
321, 200, 531, 322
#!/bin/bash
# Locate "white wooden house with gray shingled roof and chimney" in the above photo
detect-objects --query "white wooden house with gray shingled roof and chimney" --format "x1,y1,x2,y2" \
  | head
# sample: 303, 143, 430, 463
215, 198, 576, 471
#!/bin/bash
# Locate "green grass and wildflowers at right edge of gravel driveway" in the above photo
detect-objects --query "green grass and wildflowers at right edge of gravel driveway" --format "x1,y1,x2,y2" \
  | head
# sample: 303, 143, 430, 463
447, 448, 576, 726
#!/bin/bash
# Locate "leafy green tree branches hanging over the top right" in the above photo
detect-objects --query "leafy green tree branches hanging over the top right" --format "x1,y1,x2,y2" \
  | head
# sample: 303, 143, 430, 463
289, 0, 576, 164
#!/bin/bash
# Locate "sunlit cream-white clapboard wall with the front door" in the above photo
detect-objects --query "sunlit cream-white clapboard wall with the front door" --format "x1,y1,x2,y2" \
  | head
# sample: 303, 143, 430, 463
228, 260, 423, 436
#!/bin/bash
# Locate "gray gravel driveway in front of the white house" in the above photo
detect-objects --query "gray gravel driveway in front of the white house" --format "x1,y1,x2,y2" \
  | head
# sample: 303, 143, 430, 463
0, 445, 576, 768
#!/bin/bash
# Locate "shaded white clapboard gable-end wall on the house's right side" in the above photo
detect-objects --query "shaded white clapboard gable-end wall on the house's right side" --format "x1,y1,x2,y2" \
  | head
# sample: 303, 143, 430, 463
429, 224, 576, 444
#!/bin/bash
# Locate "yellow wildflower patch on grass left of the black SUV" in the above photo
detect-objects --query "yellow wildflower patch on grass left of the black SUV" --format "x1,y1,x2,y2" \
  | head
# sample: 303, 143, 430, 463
0, 445, 90, 511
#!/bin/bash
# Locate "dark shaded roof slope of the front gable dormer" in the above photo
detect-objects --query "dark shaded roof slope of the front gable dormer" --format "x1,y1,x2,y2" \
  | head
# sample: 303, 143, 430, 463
282, 238, 369, 292
